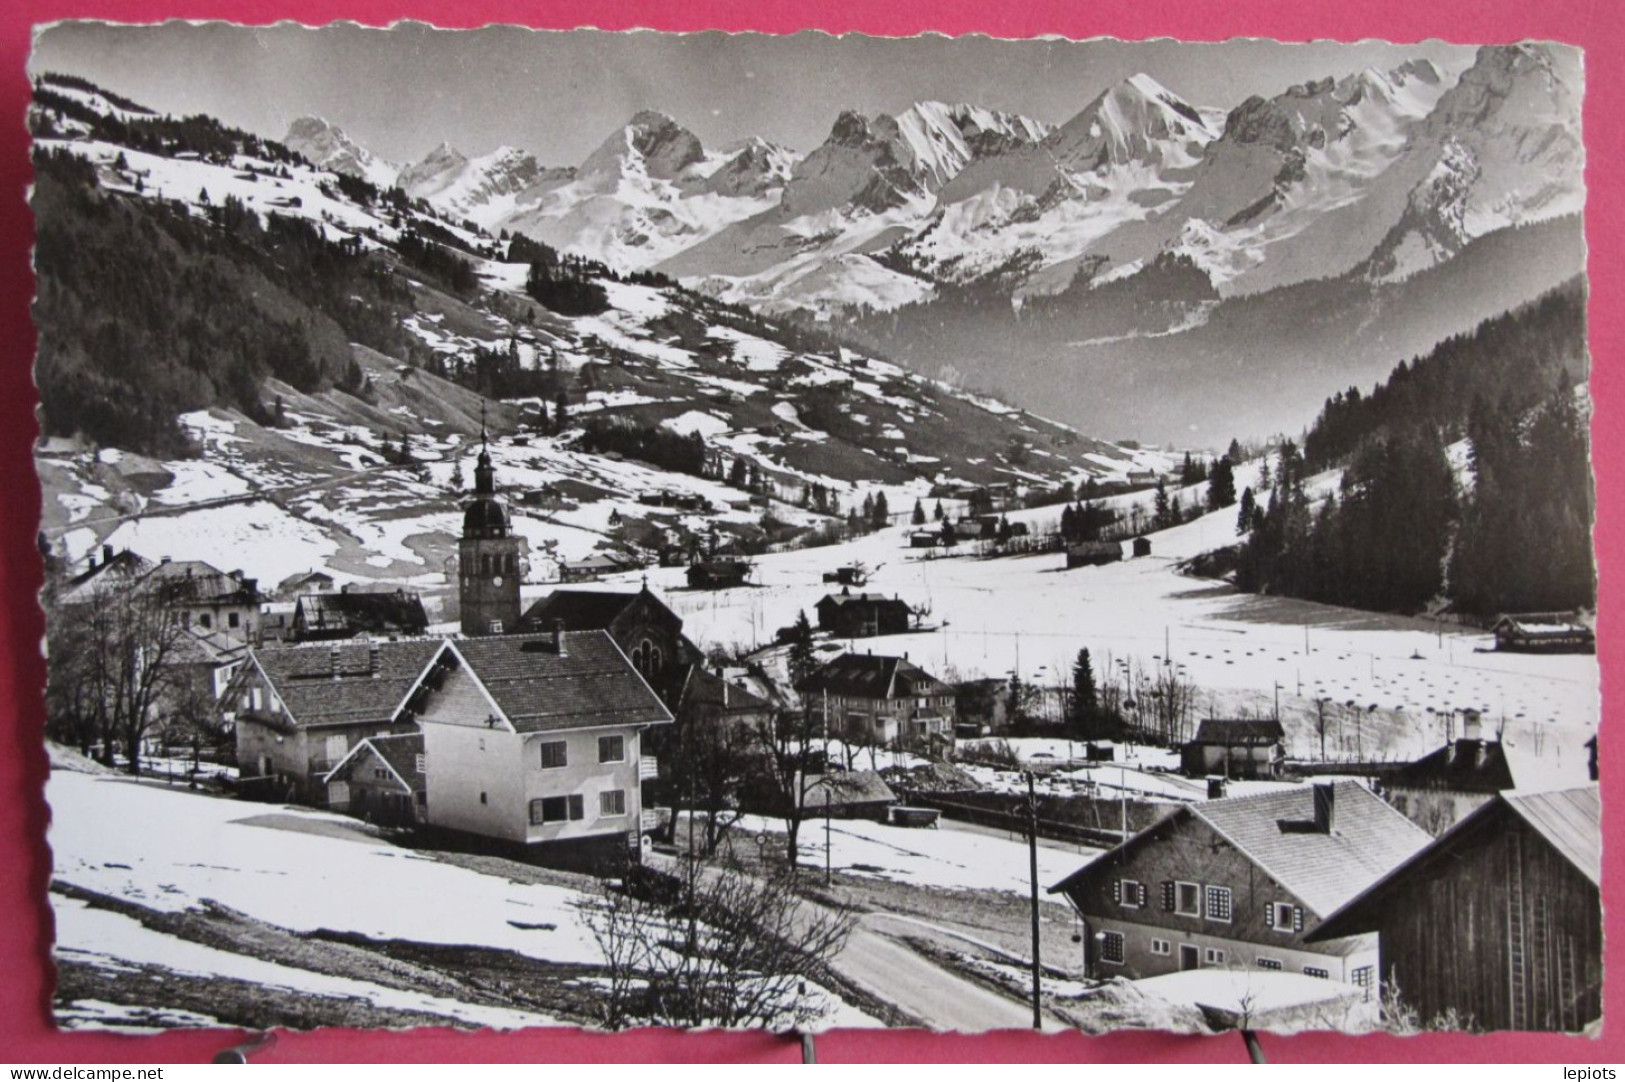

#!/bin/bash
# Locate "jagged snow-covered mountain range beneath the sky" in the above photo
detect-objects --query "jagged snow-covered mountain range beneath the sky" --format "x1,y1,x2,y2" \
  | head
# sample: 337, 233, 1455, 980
286, 44, 1584, 315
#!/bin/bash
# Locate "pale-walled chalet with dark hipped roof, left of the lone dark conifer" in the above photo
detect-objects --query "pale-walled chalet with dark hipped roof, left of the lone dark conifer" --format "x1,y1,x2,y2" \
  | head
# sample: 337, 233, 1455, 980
798, 653, 956, 751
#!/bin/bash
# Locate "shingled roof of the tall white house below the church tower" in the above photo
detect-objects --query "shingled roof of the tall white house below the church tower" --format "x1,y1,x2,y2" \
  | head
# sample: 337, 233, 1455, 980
447, 630, 671, 733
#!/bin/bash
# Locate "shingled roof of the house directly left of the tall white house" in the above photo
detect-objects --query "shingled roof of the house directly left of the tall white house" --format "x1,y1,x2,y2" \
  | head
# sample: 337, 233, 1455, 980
249, 638, 445, 726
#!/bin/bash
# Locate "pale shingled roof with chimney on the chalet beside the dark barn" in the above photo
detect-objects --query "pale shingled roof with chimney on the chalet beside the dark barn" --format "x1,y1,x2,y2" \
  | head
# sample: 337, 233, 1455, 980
1050, 781, 1430, 916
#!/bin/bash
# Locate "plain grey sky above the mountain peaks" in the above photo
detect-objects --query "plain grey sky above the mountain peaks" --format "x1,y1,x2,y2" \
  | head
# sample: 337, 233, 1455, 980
29, 23, 1472, 164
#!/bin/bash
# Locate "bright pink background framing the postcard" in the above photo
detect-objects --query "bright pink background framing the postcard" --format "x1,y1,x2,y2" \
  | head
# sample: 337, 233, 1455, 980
0, 0, 1625, 1064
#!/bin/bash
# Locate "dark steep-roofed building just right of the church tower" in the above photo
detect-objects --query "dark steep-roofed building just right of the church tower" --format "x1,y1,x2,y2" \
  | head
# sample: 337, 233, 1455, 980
518, 583, 700, 694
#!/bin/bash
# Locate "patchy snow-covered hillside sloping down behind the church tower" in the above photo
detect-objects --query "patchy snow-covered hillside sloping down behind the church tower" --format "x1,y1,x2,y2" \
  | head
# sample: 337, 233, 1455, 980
28, 74, 1175, 610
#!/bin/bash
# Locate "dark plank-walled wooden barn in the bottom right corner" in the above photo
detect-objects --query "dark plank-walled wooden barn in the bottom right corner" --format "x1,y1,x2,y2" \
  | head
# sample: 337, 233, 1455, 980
1310, 785, 1602, 1033
